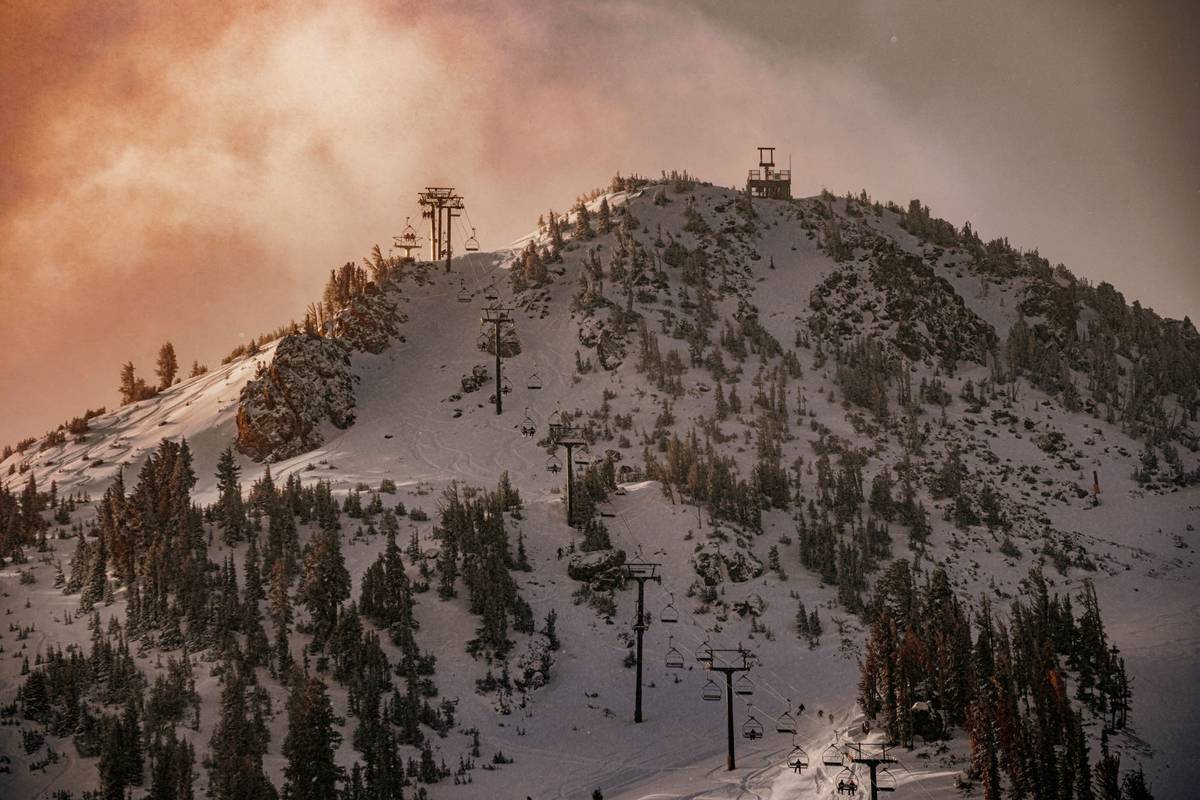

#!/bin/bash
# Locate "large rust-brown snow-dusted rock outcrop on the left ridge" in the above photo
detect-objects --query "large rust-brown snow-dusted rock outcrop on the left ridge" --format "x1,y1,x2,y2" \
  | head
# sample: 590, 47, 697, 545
238, 333, 354, 461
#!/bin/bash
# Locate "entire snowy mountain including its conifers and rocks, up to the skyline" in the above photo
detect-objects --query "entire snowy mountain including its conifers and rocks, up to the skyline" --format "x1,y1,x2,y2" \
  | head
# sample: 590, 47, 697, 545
0, 174, 1200, 798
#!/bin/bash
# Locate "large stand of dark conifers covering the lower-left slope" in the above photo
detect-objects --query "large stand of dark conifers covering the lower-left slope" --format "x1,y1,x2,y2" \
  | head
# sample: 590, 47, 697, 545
15, 440, 472, 800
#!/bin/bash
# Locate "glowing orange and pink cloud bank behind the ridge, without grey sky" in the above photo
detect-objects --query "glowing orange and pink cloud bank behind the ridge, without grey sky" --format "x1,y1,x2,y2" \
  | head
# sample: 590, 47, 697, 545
0, 0, 1195, 440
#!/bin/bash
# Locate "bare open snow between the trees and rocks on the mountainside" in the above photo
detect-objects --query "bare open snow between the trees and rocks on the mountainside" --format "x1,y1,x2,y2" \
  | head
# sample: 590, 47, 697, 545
0, 183, 1200, 800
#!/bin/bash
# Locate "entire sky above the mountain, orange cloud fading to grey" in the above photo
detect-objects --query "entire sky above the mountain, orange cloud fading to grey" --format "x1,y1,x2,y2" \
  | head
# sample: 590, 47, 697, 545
0, 0, 1200, 443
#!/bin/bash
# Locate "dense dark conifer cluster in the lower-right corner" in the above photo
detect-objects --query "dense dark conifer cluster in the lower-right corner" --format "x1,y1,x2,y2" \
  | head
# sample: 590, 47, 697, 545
859, 560, 1148, 800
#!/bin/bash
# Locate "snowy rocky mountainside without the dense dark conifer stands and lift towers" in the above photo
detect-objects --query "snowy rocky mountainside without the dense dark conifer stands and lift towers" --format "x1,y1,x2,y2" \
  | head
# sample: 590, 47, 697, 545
0, 179, 1200, 798
